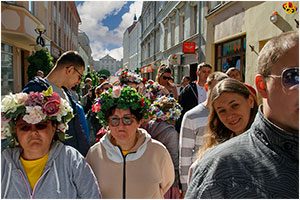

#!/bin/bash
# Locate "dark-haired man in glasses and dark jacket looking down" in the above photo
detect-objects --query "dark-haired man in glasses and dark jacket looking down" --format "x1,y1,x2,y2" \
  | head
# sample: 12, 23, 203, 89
22, 51, 89, 156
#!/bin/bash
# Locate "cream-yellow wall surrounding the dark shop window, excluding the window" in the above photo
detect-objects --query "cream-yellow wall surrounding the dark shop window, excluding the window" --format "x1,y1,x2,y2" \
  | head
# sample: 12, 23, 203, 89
206, 1, 299, 101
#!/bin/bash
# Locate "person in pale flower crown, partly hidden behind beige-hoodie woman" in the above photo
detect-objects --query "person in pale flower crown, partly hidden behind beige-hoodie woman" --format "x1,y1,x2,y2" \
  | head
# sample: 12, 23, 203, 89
145, 95, 182, 199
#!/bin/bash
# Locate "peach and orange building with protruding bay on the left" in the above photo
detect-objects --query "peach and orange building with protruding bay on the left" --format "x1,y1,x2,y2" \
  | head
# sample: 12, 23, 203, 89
1, 1, 81, 95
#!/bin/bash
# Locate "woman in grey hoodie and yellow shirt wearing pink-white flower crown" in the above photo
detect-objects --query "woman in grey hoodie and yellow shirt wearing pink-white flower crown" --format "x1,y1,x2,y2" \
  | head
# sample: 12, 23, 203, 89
1, 87, 101, 199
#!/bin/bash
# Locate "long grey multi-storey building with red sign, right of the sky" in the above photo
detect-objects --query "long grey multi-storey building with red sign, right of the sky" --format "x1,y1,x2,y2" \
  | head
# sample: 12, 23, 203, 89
141, 1, 207, 83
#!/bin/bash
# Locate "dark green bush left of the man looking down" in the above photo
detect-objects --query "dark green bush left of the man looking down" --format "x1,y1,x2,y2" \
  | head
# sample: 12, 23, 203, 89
26, 50, 54, 80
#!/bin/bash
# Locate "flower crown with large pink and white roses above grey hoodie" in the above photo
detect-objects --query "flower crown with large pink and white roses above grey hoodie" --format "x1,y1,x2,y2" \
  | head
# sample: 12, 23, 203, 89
1, 86, 74, 147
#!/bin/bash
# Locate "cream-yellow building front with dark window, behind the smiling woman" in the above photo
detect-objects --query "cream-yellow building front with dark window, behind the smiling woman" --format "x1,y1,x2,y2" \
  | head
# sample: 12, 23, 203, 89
206, 1, 299, 88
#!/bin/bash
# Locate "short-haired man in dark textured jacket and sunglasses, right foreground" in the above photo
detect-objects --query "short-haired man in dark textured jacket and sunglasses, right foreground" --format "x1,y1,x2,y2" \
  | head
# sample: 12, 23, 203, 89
186, 32, 299, 199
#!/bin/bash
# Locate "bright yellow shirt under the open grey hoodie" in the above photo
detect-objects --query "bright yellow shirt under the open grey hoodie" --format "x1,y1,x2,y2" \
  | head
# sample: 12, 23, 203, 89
20, 152, 49, 190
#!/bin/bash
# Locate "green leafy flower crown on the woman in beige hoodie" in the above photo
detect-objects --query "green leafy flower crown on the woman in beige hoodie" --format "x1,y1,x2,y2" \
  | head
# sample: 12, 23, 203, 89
92, 86, 151, 126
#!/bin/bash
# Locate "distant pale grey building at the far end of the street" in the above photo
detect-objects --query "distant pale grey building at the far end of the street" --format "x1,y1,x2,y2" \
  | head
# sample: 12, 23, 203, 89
94, 55, 123, 75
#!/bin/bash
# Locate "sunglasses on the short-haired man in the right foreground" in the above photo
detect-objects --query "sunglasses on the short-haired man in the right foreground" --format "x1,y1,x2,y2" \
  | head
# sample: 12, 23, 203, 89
267, 67, 299, 90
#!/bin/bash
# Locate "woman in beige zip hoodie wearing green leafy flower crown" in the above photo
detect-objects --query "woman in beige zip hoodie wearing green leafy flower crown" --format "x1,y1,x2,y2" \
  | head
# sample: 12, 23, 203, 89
86, 87, 174, 199
